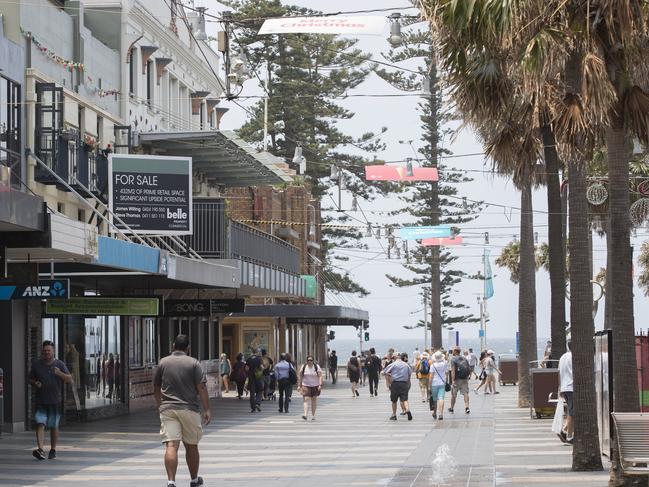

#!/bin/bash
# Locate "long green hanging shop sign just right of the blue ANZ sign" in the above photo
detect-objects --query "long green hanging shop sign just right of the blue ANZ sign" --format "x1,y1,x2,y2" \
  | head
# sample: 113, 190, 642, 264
45, 297, 162, 316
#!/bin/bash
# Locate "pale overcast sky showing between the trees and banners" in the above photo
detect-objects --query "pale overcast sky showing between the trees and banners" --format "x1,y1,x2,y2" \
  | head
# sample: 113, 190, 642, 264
205, 0, 649, 339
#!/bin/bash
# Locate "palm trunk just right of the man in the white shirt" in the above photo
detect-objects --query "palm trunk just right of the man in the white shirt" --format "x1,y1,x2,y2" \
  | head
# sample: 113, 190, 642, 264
568, 159, 603, 471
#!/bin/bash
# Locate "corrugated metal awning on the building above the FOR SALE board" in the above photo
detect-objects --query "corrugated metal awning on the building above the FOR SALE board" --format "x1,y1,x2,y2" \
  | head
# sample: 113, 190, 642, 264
138, 130, 295, 186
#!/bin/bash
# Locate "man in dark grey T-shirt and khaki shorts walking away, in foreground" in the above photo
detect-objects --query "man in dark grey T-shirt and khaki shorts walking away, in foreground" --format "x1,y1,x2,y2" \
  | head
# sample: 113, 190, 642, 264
153, 335, 212, 487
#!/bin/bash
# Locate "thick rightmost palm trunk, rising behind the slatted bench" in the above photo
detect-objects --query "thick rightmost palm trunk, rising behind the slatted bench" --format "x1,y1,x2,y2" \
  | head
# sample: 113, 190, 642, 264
606, 105, 647, 487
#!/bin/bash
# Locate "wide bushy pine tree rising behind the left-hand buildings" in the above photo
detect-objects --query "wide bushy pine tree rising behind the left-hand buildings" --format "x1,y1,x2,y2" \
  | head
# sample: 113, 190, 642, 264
221, 0, 388, 295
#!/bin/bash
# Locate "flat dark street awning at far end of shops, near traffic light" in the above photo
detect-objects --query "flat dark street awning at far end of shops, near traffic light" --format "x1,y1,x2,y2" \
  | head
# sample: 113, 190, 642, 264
232, 304, 370, 326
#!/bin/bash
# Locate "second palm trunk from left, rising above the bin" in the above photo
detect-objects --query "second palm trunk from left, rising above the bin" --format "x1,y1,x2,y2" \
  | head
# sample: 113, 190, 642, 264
540, 122, 566, 367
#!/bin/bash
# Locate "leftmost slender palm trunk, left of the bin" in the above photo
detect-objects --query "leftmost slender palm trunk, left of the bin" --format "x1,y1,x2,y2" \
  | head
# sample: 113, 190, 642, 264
518, 175, 537, 407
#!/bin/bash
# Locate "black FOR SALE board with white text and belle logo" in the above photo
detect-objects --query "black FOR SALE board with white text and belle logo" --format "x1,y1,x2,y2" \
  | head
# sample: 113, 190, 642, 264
108, 154, 192, 235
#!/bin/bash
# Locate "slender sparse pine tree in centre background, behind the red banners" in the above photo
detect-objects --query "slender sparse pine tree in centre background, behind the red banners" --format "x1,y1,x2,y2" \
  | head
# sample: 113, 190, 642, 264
377, 28, 480, 348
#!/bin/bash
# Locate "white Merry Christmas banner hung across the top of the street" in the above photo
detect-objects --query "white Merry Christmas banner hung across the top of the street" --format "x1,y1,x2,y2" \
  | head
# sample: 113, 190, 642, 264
257, 15, 387, 36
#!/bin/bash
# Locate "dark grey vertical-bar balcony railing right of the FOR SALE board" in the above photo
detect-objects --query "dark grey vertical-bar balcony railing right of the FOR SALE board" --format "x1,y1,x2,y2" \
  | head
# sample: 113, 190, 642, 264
184, 199, 300, 274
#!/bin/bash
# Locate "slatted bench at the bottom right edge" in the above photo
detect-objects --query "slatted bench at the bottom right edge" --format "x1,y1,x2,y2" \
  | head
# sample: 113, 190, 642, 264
611, 413, 649, 475
